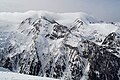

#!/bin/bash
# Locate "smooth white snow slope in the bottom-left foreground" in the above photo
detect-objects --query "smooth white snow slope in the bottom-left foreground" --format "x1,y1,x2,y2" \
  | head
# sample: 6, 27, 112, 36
0, 67, 58, 80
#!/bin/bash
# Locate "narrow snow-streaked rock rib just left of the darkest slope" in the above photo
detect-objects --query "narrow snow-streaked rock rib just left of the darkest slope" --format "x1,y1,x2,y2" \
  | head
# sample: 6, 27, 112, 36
65, 44, 85, 80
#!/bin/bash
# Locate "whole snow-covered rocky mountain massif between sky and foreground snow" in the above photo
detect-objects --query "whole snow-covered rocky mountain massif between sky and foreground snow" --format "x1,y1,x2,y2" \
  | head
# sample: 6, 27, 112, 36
0, 11, 120, 80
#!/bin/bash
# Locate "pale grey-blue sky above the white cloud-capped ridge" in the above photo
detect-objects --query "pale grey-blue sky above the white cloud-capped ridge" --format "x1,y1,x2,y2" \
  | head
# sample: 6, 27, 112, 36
0, 0, 120, 22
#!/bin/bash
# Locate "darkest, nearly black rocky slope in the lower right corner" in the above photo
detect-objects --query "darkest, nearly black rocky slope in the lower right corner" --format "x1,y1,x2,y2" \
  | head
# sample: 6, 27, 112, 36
83, 41, 120, 80
